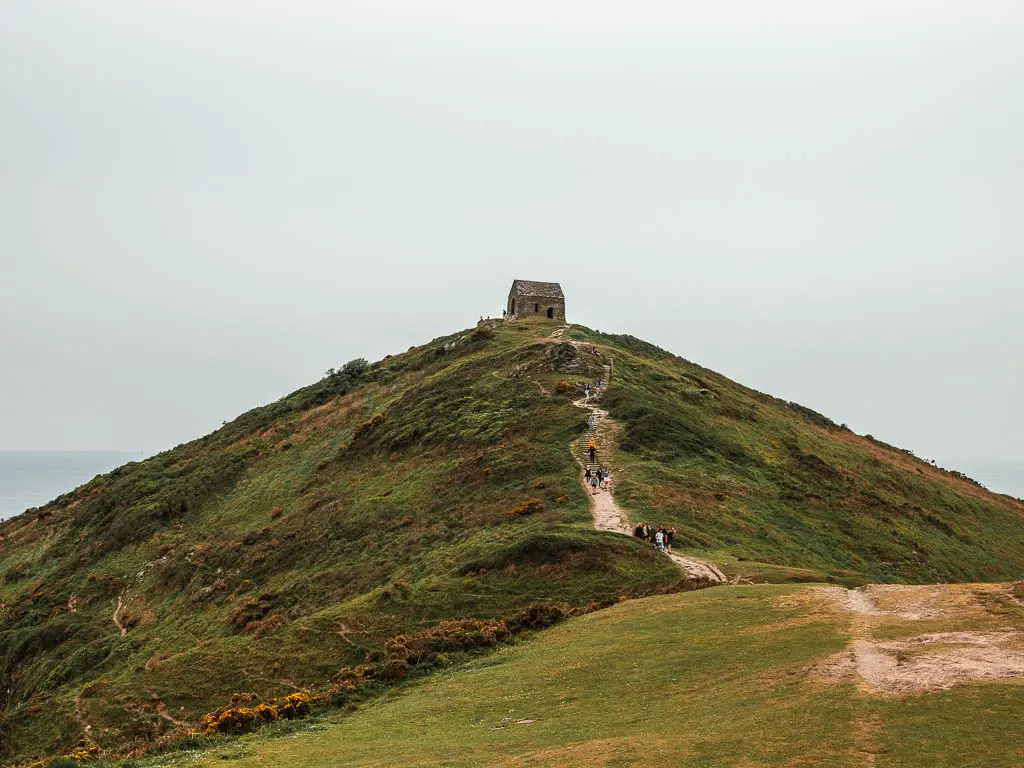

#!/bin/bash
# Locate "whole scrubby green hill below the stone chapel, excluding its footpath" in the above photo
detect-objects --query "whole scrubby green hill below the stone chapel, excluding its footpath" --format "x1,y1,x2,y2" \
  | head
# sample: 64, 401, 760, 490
0, 321, 1024, 762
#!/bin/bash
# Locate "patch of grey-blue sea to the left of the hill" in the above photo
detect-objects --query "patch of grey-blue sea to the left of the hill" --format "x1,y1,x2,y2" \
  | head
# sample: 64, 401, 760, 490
0, 451, 142, 520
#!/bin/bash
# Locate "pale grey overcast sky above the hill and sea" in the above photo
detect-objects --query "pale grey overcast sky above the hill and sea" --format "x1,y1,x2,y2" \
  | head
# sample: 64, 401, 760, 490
0, 0, 1024, 463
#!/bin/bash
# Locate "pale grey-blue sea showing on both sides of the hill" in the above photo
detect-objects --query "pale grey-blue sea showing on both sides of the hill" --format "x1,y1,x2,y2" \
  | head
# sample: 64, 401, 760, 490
0, 451, 1024, 520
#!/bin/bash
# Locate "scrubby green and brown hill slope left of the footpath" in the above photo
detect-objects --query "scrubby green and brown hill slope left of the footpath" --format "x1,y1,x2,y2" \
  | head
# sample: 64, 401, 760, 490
0, 323, 681, 756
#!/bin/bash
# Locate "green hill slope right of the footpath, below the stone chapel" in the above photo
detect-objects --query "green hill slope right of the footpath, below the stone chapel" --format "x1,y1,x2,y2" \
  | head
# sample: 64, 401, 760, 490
570, 328, 1024, 582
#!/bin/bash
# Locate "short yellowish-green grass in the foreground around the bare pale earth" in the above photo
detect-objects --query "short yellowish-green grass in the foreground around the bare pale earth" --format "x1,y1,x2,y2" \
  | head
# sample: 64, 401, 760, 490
145, 586, 1024, 768
